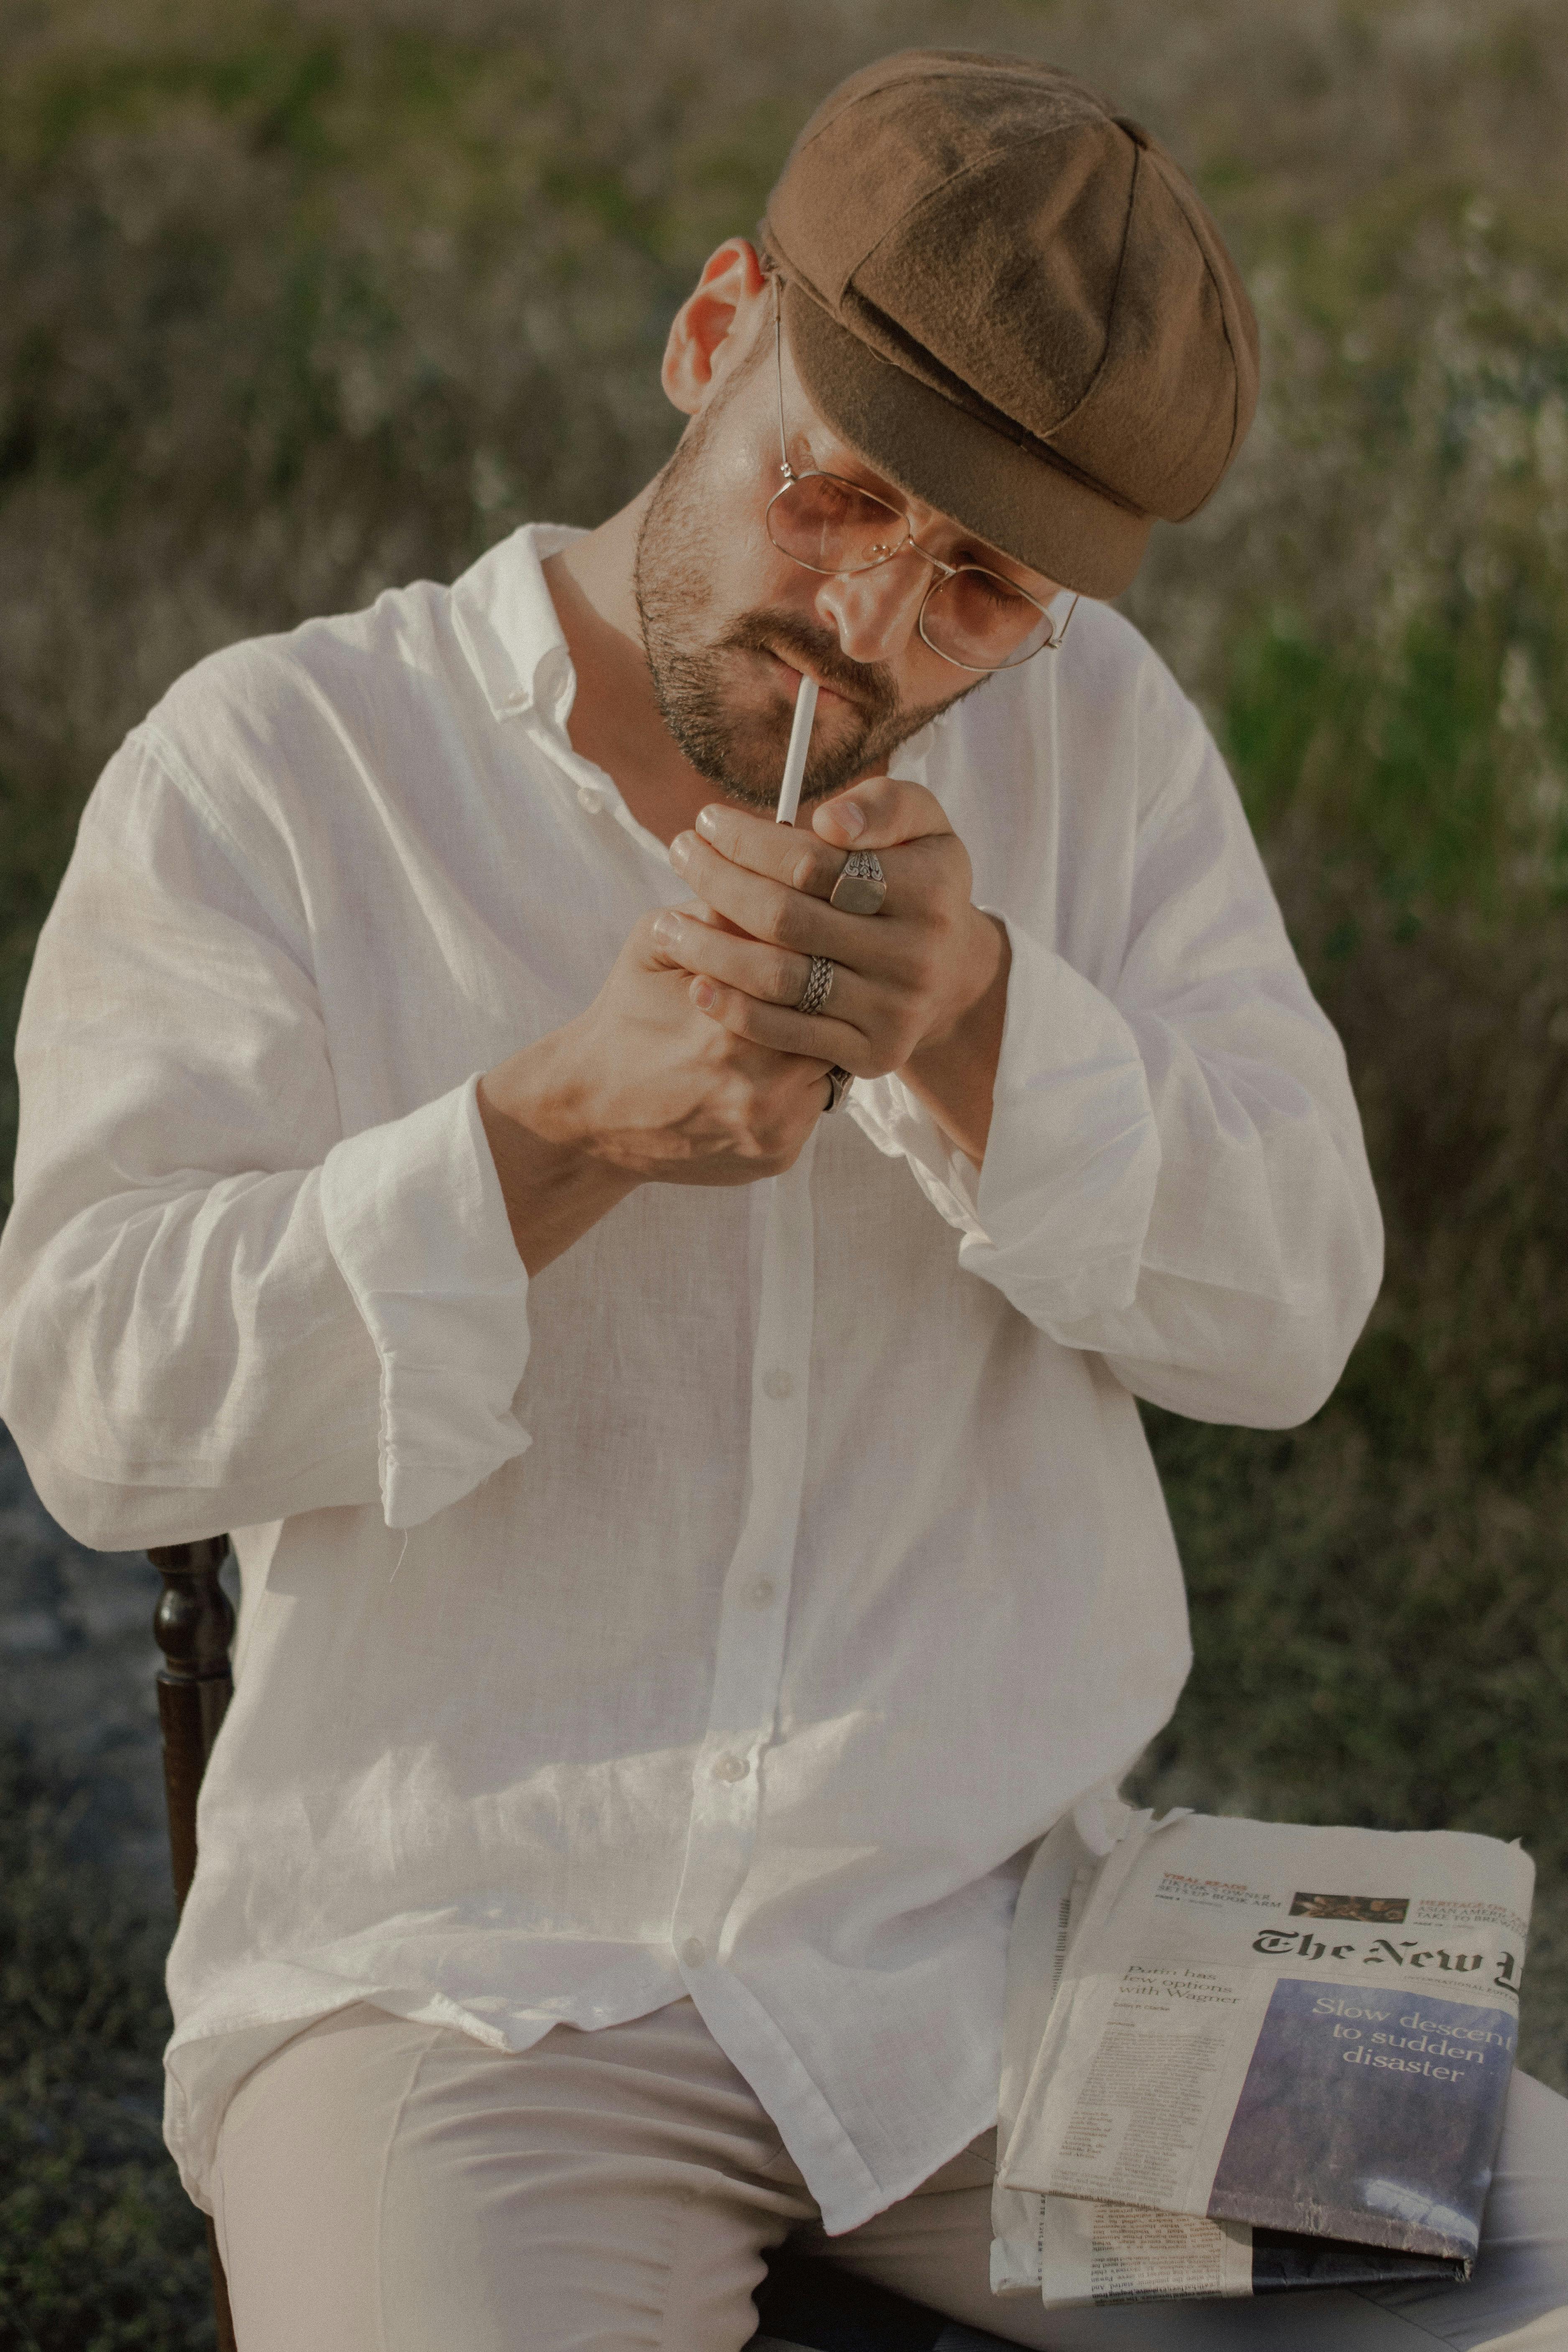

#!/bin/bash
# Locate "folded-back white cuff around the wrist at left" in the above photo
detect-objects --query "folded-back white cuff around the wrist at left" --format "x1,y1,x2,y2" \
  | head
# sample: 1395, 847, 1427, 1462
322, 1072, 531, 1526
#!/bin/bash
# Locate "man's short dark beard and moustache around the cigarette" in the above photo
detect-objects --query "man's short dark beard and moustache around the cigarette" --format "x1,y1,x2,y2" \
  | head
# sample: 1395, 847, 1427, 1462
632, 400, 983, 809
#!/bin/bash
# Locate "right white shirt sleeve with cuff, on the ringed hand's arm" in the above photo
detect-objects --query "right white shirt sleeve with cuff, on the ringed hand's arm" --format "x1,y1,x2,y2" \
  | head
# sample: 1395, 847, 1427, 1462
851, 715, 1382, 1428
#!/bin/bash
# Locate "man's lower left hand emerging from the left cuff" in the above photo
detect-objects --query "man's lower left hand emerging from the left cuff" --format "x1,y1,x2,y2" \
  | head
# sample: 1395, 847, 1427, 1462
479, 910, 830, 1275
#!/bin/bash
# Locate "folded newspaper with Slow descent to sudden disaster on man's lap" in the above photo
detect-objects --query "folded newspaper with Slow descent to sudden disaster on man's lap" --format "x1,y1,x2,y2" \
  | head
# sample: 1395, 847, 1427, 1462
992, 1797, 1535, 2305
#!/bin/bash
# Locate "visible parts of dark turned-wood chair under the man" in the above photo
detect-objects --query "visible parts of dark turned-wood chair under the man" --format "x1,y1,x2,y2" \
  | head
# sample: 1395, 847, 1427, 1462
148, 1536, 1009, 2352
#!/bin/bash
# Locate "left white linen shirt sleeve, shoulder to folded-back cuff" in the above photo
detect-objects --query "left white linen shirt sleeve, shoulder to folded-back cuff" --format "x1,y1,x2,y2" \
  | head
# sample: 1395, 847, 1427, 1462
0, 729, 529, 1550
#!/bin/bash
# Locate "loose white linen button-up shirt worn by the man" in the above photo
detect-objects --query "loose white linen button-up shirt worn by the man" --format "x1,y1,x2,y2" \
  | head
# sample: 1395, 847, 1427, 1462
0, 527, 1380, 2235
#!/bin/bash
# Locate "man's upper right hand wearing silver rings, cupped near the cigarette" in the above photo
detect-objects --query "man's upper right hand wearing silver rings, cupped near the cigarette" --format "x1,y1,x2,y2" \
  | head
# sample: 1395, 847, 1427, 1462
656, 776, 1009, 1162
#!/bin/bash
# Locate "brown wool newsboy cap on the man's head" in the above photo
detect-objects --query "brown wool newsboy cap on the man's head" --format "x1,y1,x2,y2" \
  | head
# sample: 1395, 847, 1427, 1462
762, 49, 1258, 597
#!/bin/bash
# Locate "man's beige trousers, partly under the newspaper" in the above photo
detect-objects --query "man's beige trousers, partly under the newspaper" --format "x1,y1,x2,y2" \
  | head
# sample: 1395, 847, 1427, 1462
216, 1999, 1568, 2352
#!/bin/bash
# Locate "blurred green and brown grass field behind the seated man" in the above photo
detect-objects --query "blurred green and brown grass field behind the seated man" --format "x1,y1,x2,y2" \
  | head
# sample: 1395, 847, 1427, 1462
0, 0, 1568, 2352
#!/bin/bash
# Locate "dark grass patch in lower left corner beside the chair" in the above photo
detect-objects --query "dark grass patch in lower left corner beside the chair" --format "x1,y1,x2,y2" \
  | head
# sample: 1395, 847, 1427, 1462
0, 1750, 214, 2352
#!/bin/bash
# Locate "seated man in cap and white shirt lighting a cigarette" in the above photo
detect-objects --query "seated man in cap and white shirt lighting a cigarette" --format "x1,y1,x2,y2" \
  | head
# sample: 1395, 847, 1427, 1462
0, 54, 1561, 2352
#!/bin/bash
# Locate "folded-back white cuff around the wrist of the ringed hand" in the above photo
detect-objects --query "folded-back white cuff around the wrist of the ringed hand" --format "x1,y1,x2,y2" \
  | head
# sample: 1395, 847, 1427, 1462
846, 908, 1161, 1329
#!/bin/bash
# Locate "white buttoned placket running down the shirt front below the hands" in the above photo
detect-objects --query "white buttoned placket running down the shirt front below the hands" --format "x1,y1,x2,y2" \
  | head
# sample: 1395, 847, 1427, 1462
670, 1134, 816, 1978
